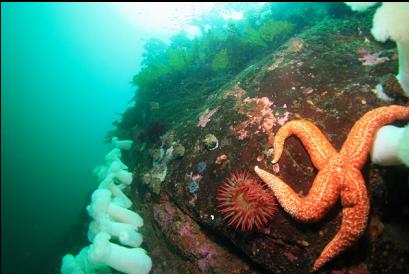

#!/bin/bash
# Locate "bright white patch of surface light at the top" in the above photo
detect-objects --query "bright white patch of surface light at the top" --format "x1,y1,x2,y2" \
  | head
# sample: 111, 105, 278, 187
114, 2, 216, 39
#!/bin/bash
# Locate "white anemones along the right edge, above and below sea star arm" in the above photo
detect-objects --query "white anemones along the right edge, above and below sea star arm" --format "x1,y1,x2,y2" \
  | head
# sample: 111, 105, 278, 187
345, 2, 409, 166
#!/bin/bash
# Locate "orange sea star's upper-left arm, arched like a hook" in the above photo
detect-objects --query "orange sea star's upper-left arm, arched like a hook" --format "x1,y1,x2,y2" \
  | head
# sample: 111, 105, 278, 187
272, 120, 337, 169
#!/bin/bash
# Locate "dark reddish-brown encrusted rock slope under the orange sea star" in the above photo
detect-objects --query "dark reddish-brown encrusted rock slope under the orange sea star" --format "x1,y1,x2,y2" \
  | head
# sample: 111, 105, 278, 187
113, 4, 409, 273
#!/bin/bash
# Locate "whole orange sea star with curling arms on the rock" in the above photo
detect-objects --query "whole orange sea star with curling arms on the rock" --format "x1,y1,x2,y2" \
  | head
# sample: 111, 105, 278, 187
255, 105, 409, 272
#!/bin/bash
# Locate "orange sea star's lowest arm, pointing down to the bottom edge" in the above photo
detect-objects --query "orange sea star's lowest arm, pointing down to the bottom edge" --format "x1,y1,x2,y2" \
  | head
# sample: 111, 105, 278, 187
311, 170, 369, 272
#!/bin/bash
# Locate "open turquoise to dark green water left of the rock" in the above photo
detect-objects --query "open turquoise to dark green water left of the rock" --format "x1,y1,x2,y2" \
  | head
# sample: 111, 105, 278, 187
1, 3, 142, 274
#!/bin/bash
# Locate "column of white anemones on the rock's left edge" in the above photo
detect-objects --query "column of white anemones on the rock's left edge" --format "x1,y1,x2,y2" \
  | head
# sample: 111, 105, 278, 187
61, 137, 152, 274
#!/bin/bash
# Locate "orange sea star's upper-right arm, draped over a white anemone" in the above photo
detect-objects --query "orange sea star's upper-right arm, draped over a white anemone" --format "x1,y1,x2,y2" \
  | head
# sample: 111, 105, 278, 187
340, 105, 409, 169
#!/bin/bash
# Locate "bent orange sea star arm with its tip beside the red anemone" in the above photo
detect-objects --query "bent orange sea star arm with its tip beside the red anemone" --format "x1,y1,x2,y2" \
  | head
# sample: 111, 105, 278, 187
254, 166, 339, 223
